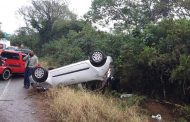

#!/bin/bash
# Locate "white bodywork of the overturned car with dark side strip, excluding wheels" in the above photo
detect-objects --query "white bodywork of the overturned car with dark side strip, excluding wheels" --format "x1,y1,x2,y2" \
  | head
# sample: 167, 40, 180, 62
40, 56, 112, 86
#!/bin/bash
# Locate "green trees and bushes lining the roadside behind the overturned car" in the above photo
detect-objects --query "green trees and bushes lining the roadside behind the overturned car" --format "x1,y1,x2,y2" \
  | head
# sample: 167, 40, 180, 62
3, 0, 190, 120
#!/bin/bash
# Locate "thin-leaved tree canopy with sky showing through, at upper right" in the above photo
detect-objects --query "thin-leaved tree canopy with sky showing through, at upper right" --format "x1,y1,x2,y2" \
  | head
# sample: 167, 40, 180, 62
86, 0, 190, 32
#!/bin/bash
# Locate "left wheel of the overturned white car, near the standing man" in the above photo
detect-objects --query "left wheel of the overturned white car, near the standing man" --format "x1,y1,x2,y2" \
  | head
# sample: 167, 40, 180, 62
32, 67, 48, 83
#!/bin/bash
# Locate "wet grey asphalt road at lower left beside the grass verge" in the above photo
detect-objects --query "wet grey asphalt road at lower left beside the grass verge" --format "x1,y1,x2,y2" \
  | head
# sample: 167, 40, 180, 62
0, 77, 38, 122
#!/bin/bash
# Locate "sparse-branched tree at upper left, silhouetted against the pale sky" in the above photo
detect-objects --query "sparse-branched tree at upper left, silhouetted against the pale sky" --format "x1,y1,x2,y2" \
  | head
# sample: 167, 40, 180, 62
19, 0, 76, 45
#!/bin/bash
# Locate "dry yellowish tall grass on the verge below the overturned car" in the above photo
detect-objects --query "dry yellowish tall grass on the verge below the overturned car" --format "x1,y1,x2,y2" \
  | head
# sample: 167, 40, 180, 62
48, 88, 148, 122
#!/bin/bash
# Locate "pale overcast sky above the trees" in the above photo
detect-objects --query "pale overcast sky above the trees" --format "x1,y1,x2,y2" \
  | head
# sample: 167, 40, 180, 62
0, 0, 91, 34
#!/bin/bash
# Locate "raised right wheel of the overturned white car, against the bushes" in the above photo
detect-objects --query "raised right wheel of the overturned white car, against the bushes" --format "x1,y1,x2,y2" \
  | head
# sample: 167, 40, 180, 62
90, 51, 107, 67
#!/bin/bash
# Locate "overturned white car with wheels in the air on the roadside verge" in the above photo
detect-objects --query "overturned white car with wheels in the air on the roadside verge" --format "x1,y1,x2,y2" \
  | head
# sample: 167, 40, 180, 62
30, 51, 112, 89
